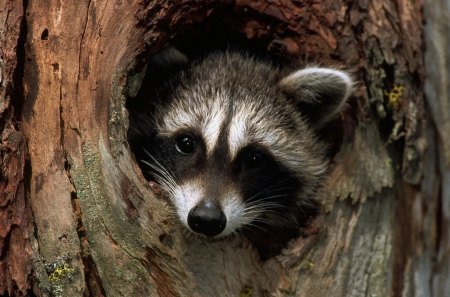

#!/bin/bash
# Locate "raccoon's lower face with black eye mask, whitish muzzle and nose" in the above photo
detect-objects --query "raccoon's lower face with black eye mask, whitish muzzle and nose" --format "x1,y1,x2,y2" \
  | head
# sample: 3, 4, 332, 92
149, 127, 300, 237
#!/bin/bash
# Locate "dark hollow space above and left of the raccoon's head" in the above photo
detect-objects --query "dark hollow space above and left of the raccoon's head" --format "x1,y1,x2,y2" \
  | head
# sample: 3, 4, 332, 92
126, 6, 301, 180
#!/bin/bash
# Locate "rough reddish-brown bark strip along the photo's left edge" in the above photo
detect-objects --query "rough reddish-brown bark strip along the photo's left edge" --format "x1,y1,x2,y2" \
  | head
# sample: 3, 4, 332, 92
0, 1, 33, 296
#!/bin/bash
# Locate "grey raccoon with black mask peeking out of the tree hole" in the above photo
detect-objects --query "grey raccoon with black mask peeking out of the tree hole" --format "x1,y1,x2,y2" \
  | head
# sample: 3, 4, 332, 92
129, 48, 353, 245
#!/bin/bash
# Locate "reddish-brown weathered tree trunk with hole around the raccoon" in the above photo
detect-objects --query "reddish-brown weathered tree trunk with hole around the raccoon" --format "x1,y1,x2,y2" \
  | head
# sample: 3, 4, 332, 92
0, 0, 450, 297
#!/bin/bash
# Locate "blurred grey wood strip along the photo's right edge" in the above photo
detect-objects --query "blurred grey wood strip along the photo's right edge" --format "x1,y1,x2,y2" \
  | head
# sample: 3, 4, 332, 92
422, 0, 450, 296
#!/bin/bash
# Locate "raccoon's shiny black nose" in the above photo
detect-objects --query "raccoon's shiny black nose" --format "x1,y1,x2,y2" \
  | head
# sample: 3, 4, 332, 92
188, 201, 227, 236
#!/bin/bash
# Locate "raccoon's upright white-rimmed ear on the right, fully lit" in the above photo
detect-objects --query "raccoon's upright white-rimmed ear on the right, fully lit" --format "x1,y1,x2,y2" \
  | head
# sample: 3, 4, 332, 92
279, 67, 353, 129
